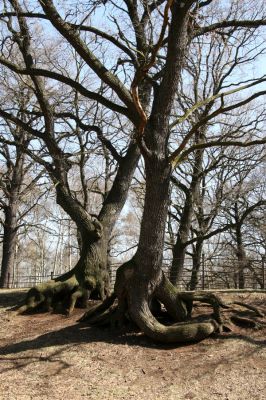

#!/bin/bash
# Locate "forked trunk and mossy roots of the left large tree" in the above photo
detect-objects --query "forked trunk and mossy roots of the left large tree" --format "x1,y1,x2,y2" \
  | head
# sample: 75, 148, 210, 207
19, 142, 142, 314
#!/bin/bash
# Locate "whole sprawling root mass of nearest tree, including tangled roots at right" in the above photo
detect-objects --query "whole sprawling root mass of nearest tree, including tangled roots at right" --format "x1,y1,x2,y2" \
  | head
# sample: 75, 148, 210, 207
80, 261, 262, 343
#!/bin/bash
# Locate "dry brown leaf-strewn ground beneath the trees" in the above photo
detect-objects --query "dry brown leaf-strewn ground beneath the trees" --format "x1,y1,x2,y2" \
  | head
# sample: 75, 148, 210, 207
0, 290, 266, 400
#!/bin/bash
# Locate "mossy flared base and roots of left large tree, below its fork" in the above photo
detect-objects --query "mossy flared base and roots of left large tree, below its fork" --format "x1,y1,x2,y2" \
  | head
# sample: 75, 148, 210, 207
17, 220, 110, 315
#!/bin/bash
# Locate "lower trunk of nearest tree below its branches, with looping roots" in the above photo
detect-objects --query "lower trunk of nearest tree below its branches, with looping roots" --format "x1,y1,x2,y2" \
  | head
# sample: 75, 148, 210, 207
82, 164, 221, 342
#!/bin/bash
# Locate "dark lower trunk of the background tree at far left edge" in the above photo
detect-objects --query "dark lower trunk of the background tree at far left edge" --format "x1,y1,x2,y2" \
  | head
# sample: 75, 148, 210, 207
0, 204, 17, 288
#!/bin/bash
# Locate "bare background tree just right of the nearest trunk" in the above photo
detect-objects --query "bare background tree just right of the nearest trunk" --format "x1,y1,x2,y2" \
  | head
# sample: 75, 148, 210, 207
167, 21, 265, 286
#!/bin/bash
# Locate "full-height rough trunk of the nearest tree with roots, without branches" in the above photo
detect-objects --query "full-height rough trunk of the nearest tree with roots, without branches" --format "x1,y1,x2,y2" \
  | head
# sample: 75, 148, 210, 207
83, 2, 227, 342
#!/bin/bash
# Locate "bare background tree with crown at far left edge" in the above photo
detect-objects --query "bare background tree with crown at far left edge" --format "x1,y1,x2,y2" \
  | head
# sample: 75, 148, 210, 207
0, 79, 46, 287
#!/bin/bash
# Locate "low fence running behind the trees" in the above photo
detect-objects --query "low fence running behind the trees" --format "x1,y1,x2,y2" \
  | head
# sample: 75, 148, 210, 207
7, 257, 265, 290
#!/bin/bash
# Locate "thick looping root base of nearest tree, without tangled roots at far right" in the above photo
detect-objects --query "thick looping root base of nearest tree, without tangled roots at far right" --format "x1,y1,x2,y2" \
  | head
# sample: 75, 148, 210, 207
81, 261, 220, 343
